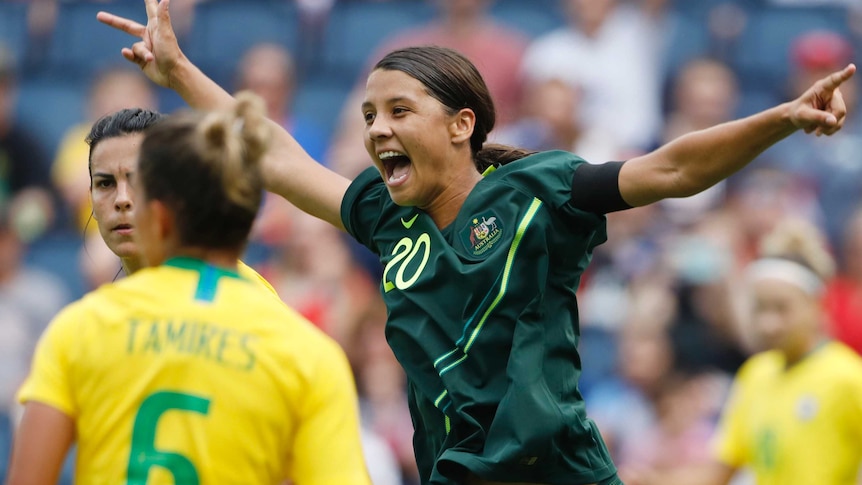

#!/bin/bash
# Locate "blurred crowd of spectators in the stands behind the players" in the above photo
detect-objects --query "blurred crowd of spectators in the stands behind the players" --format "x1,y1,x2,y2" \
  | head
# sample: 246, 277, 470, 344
0, 0, 862, 484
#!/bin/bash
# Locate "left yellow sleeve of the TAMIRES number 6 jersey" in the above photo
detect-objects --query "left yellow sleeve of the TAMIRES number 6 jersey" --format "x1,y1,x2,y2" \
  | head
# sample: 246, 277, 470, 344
17, 303, 85, 417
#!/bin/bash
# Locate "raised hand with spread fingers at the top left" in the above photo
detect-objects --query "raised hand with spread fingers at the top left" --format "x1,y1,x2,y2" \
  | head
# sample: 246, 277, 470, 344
96, 0, 185, 87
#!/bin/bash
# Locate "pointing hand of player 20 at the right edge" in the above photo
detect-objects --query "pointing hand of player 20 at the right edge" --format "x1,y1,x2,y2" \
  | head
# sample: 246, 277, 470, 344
790, 64, 856, 136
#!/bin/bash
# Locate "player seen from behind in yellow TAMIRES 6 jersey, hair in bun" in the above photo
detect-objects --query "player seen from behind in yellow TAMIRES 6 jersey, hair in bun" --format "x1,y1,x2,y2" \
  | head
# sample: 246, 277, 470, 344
9, 95, 369, 485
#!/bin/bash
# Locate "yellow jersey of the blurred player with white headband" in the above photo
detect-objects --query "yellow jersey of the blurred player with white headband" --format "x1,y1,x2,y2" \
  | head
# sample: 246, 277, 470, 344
715, 342, 862, 485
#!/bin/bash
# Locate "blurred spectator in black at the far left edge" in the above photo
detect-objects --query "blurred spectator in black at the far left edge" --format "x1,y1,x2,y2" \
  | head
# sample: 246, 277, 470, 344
0, 45, 55, 241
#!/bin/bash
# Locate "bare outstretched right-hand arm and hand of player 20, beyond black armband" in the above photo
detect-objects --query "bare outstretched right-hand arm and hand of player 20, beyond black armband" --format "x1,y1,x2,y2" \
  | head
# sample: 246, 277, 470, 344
619, 64, 856, 206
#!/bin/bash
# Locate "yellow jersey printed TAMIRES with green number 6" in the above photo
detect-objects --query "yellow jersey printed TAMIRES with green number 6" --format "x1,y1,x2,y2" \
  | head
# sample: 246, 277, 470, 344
18, 258, 370, 485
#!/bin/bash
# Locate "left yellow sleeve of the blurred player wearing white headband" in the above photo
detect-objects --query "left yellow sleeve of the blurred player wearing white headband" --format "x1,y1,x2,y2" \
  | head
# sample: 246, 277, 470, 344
711, 366, 751, 468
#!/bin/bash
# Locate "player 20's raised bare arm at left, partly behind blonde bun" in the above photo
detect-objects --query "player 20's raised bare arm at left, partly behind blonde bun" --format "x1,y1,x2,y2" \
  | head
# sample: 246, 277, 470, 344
97, 0, 350, 229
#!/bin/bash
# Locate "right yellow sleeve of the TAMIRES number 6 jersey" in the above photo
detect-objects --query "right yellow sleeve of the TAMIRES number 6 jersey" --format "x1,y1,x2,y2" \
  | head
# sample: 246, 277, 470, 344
291, 336, 371, 485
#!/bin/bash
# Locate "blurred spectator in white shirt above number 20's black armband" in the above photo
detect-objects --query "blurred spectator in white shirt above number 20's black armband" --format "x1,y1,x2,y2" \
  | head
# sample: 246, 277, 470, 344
521, 0, 665, 161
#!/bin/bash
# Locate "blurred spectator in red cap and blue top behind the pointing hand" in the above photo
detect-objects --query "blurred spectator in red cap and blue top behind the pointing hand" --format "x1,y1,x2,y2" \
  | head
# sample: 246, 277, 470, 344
763, 31, 862, 250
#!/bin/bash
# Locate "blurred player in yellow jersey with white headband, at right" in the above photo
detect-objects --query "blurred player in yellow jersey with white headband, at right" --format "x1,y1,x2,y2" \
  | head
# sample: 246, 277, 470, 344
712, 223, 862, 485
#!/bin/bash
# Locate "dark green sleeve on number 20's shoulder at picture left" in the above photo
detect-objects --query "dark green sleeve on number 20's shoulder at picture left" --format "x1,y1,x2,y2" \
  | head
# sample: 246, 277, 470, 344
341, 167, 389, 254
